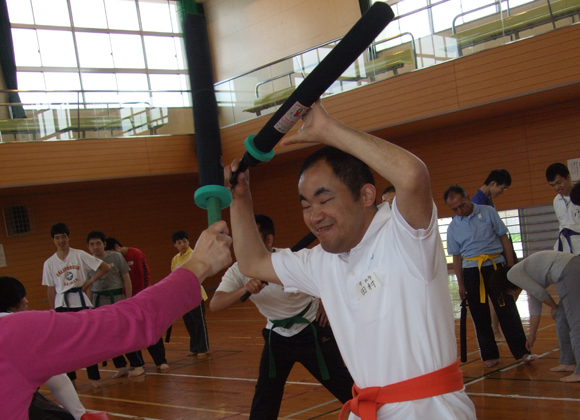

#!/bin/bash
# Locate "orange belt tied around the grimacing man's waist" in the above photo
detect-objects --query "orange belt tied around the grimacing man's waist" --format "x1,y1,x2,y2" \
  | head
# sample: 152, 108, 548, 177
339, 360, 463, 420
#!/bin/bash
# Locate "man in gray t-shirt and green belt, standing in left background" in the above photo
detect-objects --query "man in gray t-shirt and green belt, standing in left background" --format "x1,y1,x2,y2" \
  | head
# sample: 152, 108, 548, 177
83, 230, 145, 378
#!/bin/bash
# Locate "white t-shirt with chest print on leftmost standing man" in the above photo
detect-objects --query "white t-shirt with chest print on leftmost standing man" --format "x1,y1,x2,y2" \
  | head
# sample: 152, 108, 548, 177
42, 248, 103, 308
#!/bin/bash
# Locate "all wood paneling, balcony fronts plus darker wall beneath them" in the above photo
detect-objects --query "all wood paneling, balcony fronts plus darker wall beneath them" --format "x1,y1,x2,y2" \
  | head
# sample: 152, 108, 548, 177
0, 23, 580, 309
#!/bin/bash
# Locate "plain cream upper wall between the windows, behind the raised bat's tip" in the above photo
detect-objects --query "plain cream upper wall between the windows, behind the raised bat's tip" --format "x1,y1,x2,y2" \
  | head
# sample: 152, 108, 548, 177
203, 0, 361, 81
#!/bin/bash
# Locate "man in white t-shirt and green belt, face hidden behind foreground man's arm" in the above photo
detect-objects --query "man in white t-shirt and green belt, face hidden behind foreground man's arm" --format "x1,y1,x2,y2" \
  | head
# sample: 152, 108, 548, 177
209, 214, 353, 420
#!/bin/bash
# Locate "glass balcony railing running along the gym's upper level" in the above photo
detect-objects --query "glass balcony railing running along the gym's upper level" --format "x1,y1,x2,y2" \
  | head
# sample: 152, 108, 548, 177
0, 0, 580, 142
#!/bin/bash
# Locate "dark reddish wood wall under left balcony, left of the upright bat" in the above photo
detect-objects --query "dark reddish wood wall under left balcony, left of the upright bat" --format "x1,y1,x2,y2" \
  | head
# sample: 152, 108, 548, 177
0, 174, 207, 309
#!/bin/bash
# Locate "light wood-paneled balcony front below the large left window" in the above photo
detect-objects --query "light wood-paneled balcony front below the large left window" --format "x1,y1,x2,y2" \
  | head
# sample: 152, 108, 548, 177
0, 135, 197, 188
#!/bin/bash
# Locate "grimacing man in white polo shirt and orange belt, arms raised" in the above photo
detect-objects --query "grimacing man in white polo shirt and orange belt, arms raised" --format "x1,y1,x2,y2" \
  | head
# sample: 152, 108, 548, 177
225, 102, 475, 420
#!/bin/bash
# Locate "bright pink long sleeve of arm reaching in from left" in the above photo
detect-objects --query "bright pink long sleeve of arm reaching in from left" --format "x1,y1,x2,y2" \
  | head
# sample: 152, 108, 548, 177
0, 268, 201, 386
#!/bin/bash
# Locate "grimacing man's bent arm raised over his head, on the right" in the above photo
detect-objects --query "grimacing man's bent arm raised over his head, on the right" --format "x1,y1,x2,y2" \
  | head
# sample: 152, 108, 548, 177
280, 102, 434, 229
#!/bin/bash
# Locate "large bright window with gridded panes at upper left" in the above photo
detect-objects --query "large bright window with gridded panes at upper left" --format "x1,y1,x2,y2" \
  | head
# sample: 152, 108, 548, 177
7, 0, 190, 106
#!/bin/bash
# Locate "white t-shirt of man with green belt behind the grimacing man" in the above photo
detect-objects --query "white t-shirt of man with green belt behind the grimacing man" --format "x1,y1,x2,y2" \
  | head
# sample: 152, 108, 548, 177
216, 253, 319, 337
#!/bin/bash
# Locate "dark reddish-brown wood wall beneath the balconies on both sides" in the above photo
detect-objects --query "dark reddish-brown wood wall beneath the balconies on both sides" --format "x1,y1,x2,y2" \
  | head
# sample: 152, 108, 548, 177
0, 92, 580, 309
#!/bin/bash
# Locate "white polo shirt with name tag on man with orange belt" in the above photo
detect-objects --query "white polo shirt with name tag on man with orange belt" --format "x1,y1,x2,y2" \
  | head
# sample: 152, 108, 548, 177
272, 200, 475, 420
